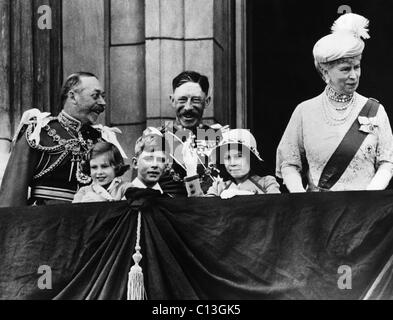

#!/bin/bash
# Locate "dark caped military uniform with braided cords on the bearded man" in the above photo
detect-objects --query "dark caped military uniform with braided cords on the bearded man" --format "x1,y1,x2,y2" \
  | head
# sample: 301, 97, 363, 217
0, 112, 101, 207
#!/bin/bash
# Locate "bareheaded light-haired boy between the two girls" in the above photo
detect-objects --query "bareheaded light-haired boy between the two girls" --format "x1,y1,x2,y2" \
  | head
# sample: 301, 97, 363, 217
132, 128, 169, 194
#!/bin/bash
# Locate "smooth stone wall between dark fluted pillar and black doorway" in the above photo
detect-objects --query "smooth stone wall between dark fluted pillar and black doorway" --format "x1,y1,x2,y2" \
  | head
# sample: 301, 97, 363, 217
63, 0, 235, 156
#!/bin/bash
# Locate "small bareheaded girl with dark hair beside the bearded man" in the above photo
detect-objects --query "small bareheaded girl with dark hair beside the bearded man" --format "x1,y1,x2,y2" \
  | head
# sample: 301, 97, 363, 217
73, 142, 132, 203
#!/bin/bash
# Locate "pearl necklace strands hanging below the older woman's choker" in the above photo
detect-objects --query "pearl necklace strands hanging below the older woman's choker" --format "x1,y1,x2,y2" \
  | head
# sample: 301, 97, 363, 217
322, 95, 356, 126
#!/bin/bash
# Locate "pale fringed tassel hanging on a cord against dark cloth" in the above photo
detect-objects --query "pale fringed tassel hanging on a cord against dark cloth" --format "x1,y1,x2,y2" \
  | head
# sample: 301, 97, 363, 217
127, 211, 145, 300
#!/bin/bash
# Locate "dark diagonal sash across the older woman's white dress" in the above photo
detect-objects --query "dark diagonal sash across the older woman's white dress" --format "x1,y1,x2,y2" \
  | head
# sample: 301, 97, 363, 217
318, 98, 379, 190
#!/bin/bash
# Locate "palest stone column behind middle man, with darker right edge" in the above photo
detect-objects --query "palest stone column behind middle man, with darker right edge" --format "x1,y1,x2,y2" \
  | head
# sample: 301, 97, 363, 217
145, 0, 233, 126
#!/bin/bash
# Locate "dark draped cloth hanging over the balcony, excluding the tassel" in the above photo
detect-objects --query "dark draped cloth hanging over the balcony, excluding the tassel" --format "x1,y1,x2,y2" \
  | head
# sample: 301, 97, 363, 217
0, 191, 393, 300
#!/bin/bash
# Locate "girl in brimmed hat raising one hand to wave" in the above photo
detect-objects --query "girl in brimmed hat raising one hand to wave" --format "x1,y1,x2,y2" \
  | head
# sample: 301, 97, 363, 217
183, 129, 280, 199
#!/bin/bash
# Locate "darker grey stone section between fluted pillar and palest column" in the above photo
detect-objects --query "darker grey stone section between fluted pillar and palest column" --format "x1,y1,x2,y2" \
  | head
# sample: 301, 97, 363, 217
63, 0, 146, 157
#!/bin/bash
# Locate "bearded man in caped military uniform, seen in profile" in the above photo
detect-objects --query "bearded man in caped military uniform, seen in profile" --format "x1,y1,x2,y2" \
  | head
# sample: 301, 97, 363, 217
0, 72, 106, 207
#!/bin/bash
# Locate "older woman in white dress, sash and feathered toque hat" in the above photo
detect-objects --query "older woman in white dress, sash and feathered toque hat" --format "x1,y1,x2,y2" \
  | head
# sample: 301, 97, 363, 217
276, 13, 393, 192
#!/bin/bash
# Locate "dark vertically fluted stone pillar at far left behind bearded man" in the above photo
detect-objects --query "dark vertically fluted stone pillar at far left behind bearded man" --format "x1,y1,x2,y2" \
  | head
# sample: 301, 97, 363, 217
0, 0, 62, 178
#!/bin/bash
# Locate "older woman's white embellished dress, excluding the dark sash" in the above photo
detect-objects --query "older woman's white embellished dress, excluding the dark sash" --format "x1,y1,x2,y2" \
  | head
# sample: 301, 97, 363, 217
276, 92, 393, 191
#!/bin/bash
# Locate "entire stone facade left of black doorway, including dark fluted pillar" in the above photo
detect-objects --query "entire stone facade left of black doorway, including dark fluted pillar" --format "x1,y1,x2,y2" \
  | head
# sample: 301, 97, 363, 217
0, 0, 236, 172
